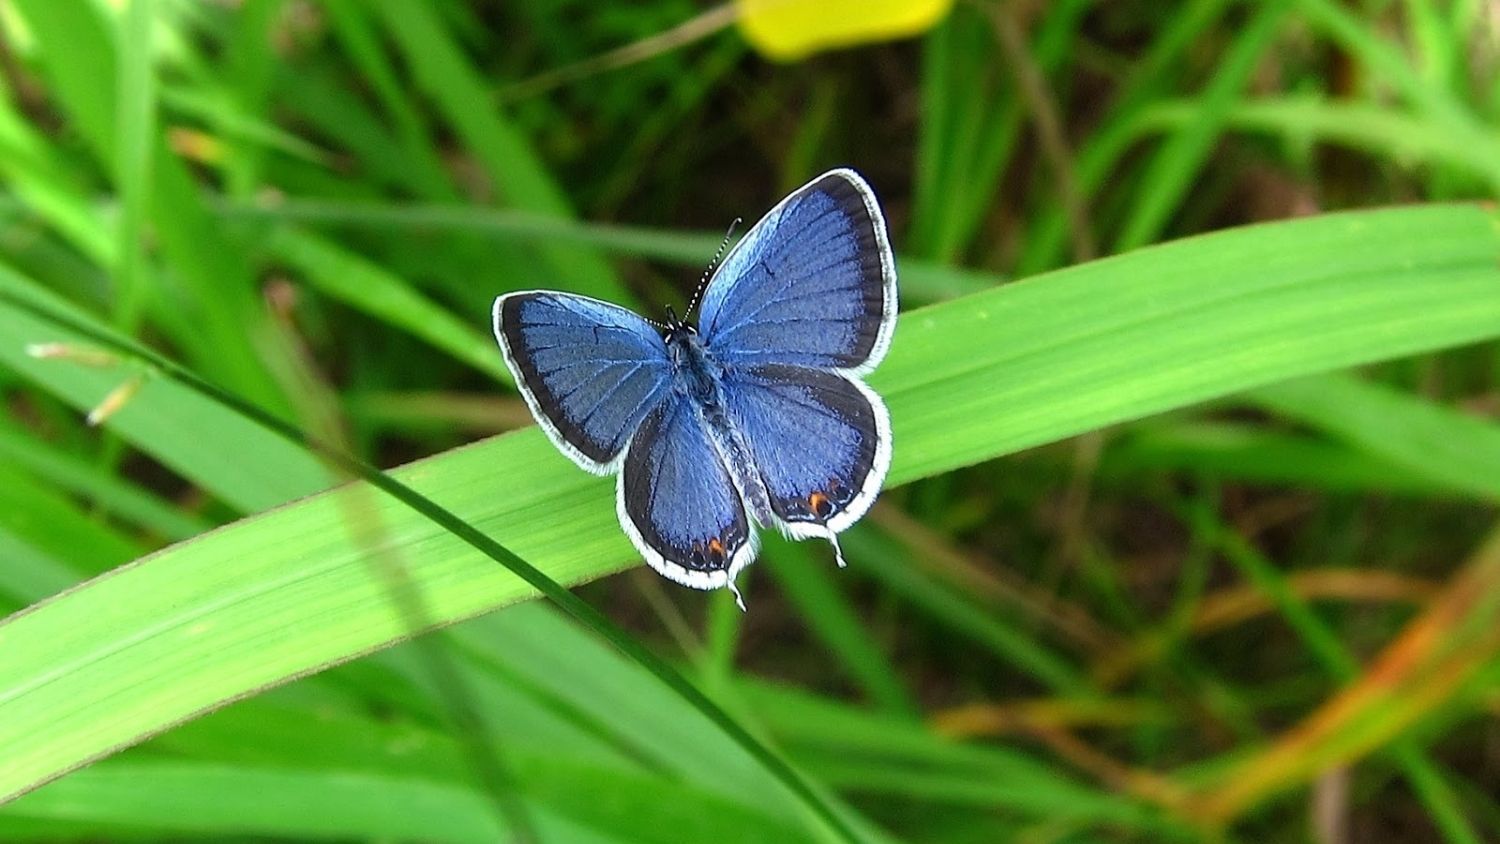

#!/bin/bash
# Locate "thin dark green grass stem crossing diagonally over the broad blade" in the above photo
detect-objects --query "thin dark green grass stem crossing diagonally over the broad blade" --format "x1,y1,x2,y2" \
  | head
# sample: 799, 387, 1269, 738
0, 289, 860, 841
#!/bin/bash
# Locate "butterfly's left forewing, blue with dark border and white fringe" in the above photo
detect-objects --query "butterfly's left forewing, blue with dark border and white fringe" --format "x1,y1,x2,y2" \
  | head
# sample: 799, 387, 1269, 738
495, 291, 672, 474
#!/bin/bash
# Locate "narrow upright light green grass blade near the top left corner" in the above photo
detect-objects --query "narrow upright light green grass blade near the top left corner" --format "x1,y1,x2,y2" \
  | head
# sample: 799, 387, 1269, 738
114, 0, 156, 334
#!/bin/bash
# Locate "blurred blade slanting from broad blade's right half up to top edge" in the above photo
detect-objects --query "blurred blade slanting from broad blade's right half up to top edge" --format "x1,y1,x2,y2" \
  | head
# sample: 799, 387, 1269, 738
1115, 0, 1293, 252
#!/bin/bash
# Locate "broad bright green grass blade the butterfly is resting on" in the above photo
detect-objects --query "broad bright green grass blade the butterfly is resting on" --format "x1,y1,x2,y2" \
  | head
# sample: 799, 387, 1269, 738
0, 205, 1500, 795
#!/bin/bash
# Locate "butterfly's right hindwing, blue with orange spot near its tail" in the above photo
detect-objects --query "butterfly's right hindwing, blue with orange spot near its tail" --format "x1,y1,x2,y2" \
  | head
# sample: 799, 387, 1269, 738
725, 366, 891, 538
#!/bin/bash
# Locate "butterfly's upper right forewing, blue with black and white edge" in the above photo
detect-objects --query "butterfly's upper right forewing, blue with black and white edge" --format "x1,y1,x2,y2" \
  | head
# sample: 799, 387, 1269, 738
699, 169, 896, 372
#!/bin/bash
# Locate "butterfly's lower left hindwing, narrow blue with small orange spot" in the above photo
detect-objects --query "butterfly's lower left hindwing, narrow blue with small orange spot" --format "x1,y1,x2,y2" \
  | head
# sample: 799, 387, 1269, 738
617, 393, 756, 589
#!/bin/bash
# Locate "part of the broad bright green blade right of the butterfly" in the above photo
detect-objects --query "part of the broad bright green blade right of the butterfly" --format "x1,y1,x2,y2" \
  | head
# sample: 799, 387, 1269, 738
870, 205, 1500, 481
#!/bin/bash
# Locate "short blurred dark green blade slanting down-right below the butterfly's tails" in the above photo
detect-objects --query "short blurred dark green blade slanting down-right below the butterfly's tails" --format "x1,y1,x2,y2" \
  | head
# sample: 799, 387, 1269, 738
762, 540, 918, 718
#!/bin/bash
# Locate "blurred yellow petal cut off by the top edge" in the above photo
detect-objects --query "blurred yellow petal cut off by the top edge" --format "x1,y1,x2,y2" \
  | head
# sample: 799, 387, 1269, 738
738, 0, 953, 61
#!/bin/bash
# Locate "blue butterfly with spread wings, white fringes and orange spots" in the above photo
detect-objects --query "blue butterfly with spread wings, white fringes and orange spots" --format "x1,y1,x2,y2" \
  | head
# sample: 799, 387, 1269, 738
495, 169, 897, 609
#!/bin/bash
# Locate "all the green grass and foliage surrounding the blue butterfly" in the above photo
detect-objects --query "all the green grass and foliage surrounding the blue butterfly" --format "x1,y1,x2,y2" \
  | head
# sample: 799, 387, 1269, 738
0, 0, 1500, 844
